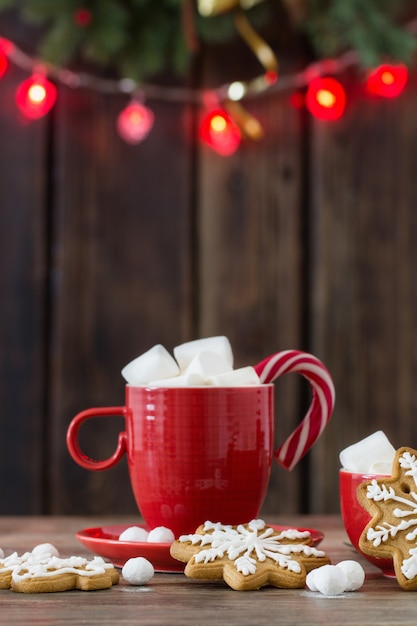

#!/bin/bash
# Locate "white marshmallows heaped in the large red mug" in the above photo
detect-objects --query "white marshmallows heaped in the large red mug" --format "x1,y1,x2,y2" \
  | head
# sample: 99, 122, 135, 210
122, 336, 260, 387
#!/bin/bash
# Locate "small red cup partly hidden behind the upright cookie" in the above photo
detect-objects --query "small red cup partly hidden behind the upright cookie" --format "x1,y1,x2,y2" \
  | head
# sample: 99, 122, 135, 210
339, 469, 395, 578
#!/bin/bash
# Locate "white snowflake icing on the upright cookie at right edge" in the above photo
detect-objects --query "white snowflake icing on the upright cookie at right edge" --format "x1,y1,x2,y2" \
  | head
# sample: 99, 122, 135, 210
366, 452, 417, 580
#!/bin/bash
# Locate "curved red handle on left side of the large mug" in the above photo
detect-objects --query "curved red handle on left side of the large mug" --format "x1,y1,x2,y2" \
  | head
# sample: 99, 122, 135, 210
67, 406, 128, 471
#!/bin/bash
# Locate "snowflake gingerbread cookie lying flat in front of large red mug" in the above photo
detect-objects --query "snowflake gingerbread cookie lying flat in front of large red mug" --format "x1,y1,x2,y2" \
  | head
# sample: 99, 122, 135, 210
171, 519, 330, 591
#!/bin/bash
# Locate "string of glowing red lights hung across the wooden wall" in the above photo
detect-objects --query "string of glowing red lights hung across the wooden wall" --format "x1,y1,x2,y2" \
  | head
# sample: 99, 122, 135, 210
0, 32, 417, 156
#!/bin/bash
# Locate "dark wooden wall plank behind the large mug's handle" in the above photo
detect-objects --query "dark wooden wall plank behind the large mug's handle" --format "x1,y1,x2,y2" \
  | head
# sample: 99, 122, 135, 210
49, 85, 196, 513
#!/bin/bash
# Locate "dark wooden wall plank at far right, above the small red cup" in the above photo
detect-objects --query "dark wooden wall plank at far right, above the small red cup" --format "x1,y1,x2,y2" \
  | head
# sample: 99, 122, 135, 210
310, 66, 417, 511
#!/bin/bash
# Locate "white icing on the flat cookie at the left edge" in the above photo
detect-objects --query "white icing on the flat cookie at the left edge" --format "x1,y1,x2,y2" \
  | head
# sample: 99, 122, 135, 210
0, 552, 113, 582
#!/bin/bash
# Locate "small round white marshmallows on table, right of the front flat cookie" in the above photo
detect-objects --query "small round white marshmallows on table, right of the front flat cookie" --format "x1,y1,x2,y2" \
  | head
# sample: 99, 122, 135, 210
306, 561, 365, 596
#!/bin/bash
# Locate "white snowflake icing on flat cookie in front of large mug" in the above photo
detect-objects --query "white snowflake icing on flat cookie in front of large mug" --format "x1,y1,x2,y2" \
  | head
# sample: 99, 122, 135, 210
179, 519, 325, 576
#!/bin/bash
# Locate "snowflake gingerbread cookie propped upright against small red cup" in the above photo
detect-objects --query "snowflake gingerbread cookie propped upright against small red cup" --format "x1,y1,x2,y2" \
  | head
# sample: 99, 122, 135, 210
357, 447, 417, 590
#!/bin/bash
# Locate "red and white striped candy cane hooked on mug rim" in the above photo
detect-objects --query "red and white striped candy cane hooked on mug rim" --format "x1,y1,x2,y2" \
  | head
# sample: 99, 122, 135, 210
255, 350, 335, 470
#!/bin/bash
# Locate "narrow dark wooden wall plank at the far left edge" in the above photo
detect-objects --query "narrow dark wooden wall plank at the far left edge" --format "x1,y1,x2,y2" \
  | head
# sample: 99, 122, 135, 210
0, 57, 48, 513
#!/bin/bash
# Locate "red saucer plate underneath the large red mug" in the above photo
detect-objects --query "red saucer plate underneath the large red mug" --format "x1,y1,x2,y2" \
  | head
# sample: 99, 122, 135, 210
76, 524, 324, 572
